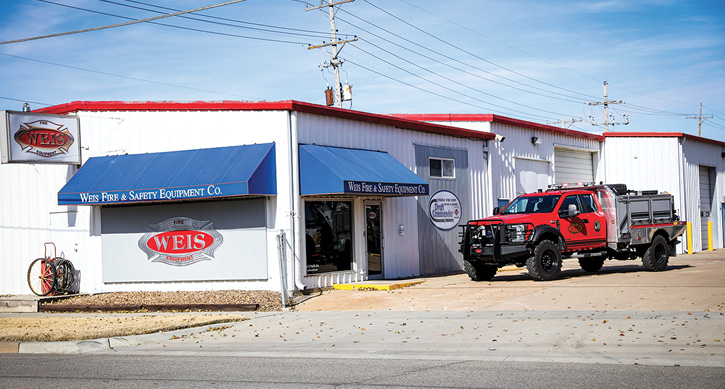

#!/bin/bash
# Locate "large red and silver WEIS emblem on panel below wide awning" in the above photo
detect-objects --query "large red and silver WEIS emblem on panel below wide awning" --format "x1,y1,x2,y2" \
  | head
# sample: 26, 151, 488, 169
138, 217, 223, 266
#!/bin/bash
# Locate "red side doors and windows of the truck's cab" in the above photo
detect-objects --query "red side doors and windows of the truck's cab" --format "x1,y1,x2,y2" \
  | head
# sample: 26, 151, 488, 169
559, 193, 607, 251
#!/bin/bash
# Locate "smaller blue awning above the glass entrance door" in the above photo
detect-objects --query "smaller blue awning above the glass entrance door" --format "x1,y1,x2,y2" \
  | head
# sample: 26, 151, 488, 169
300, 145, 428, 196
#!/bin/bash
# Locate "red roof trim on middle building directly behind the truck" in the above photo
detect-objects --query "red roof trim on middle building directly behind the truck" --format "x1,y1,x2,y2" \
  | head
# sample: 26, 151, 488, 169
391, 113, 604, 142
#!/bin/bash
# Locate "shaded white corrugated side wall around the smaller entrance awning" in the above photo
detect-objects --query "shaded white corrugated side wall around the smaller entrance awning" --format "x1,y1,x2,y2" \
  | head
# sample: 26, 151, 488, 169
297, 113, 490, 286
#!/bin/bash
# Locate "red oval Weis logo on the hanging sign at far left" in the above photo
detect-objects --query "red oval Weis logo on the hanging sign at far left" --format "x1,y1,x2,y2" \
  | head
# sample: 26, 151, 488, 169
14, 120, 74, 158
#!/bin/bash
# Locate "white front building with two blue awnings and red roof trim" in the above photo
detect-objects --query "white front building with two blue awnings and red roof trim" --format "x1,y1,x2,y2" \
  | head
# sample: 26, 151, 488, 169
0, 101, 494, 293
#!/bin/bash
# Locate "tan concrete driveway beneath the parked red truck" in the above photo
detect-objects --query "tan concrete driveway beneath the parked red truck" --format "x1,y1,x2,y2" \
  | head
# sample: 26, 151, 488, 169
295, 249, 725, 312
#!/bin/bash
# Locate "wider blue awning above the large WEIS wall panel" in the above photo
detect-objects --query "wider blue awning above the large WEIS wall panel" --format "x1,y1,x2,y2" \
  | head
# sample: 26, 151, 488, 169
58, 143, 277, 205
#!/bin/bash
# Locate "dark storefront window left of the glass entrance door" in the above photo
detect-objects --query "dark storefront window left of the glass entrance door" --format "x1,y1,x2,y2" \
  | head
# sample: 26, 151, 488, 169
305, 201, 352, 274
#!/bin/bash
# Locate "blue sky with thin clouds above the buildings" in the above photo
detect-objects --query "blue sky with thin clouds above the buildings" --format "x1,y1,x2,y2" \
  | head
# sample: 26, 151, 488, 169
0, 0, 725, 141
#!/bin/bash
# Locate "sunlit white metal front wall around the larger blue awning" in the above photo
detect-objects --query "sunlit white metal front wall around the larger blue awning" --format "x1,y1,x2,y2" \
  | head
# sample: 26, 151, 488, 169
0, 111, 291, 294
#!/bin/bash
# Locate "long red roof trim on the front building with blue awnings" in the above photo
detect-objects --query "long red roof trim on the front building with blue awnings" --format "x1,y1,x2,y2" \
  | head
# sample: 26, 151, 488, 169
35, 100, 496, 140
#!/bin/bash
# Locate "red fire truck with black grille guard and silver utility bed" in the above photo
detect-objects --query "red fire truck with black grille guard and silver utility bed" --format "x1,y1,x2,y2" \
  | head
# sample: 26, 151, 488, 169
460, 184, 686, 281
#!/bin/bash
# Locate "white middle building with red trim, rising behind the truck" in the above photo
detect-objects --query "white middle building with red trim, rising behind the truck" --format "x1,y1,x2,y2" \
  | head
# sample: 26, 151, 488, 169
395, 114, 605, 208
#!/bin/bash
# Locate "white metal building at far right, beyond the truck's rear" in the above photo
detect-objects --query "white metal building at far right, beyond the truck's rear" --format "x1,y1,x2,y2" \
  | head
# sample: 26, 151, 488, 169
604, 132, 725, 252
